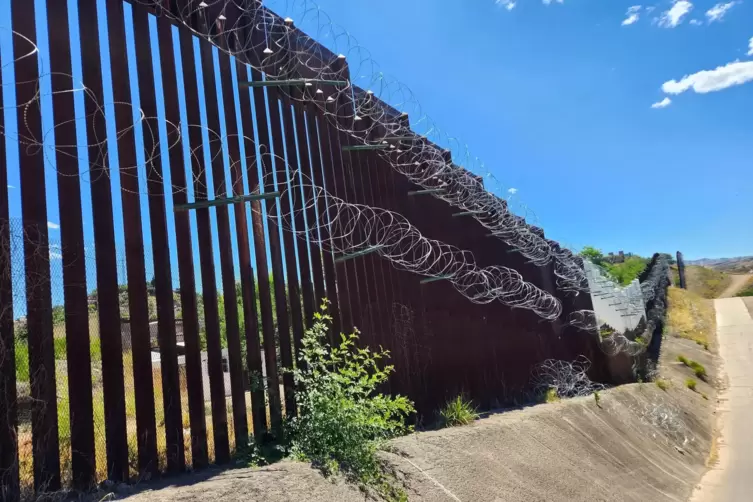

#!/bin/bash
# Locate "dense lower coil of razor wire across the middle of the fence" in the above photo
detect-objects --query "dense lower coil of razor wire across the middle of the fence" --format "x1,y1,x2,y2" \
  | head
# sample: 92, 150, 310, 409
265, 171, 562, 320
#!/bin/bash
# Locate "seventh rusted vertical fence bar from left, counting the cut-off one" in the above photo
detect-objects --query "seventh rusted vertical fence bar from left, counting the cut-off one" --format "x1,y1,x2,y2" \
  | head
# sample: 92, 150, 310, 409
157, 18, 209, 469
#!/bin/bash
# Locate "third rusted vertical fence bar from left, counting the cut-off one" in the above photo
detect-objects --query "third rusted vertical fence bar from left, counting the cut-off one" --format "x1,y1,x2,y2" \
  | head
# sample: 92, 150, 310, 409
47, 0, 95, 490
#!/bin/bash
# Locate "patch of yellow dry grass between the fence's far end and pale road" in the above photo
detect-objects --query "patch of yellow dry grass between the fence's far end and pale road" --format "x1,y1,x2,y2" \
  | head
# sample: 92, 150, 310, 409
665, 287, 716, 348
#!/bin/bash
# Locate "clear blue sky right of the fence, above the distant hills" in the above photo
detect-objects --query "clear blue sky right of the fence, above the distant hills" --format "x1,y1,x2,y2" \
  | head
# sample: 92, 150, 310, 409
278, 0, 753, 258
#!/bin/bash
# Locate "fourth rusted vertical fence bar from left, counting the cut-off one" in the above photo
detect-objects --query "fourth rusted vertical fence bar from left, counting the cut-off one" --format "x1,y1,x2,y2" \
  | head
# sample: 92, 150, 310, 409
78, 0, 128, 481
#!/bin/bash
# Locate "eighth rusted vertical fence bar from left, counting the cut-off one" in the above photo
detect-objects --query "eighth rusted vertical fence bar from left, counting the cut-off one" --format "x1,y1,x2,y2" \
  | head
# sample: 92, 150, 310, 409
179, 24, 230, 464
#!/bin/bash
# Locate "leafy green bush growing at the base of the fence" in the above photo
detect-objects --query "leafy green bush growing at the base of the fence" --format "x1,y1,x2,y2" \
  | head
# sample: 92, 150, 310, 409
288, 302, 415, 495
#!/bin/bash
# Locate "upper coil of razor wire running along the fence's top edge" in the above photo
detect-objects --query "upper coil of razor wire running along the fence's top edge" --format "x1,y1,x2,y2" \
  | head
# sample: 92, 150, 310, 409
89, 0, 587, 292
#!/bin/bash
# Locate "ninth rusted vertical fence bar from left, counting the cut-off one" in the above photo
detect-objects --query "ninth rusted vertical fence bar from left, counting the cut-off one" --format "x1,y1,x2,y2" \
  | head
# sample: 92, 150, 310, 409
195, 42, 248, 449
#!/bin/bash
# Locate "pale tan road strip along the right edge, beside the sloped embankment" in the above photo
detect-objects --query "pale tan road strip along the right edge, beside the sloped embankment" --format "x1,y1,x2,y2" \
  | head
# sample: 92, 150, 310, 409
691, 298, 753, 502
